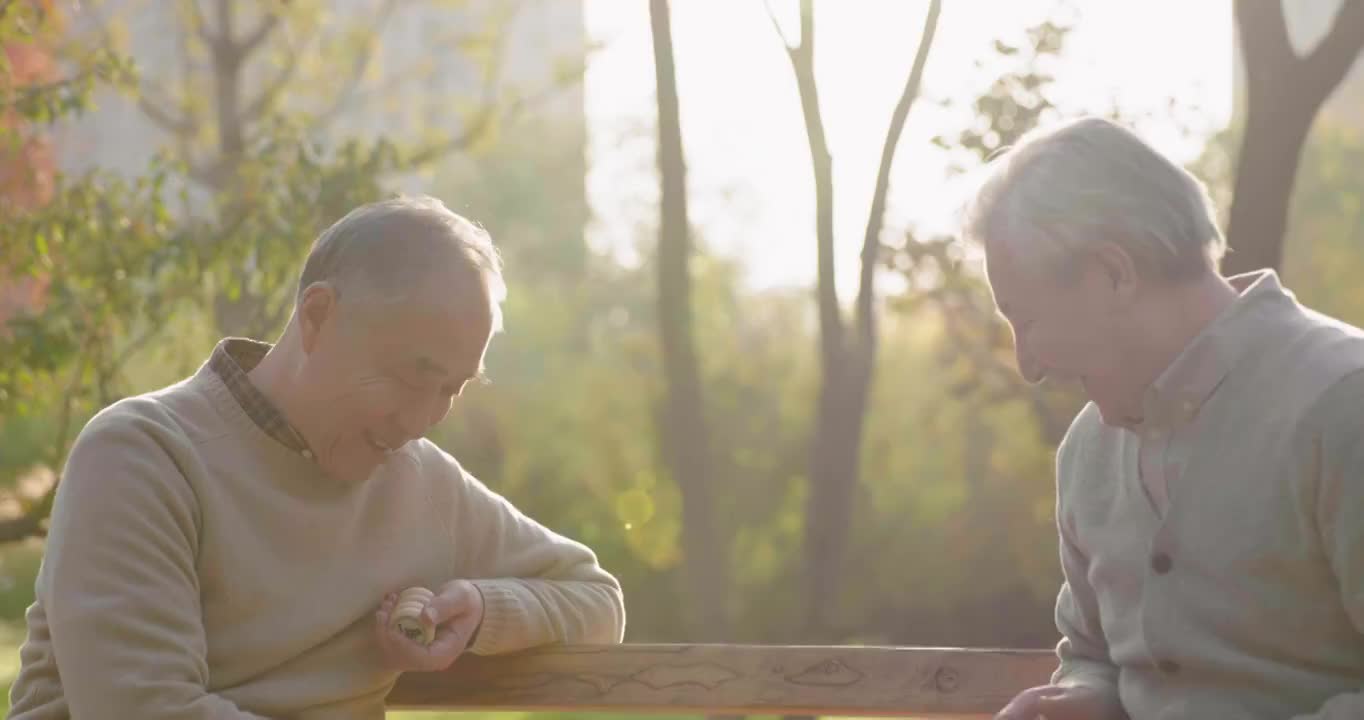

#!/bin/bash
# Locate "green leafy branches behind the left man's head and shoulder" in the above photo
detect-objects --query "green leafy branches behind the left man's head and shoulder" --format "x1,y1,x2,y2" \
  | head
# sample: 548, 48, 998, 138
0, 120, 391, 471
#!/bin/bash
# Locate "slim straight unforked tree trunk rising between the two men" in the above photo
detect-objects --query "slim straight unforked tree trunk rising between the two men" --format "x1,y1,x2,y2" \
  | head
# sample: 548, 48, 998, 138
649, 0, 728, 641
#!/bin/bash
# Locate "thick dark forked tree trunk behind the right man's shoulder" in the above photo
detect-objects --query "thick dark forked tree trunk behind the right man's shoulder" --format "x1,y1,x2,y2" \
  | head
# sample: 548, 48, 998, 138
1222, 0, 1364, 275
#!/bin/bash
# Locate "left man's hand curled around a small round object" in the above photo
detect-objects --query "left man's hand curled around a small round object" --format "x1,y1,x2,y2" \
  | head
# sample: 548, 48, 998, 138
375, 580, 483, 672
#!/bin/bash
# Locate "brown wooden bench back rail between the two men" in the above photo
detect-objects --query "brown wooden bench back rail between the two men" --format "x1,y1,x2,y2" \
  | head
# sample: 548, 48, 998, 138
389, 645, 1056, 719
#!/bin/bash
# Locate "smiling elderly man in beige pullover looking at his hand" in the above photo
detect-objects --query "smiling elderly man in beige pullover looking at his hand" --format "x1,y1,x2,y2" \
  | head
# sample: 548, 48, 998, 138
10, 198, 625, 720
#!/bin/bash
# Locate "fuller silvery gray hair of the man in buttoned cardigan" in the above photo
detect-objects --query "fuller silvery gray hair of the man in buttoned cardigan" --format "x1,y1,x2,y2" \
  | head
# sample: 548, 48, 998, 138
963, 117, 1226, 282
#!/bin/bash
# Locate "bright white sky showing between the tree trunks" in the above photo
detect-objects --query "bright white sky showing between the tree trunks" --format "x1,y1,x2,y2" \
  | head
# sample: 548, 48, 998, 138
585, 0, 1233, 291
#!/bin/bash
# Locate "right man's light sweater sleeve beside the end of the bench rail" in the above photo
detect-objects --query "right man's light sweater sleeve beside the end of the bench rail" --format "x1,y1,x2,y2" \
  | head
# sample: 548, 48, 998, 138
1052, 413, 1118, 705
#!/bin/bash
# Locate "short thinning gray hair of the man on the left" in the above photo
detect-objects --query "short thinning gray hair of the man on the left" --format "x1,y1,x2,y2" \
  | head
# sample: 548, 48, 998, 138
299, 195, 506, 330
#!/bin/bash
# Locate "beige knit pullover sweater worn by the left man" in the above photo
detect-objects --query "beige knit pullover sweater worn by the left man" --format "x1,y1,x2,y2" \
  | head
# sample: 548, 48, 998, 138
10, 357, 625, 720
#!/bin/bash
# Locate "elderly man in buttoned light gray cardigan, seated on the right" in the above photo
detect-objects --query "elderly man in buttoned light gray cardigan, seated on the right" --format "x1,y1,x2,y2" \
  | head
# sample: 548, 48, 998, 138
982, 119, 1364, 720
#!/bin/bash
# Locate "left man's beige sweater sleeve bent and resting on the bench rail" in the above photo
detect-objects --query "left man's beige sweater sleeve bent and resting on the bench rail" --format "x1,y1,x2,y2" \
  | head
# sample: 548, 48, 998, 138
422, 446, 625, 655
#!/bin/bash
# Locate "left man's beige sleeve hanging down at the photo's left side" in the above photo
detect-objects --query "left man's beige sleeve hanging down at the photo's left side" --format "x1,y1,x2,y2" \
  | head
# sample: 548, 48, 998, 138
37, 401, 274, 720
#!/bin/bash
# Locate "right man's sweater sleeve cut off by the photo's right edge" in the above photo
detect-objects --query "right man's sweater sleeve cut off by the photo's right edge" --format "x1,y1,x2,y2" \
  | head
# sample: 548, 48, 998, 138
1293, 371, 1364, 720
